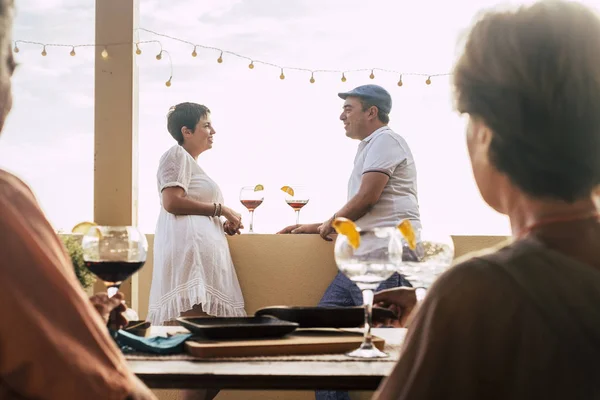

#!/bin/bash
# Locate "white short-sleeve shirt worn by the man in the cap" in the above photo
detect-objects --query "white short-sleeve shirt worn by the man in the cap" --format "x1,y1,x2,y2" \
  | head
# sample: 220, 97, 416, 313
348, 126, 421, 229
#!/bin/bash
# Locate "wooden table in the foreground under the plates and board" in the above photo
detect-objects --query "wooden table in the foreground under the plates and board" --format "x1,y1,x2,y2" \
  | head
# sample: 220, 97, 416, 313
129, 328, 405, 390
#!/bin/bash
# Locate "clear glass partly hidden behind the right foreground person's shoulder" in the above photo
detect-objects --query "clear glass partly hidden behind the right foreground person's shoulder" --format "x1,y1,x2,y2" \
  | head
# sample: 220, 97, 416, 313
397, 227, 454, 300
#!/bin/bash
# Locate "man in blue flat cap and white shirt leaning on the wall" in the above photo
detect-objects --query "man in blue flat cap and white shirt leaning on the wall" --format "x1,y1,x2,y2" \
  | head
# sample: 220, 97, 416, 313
279, 85, 421, 400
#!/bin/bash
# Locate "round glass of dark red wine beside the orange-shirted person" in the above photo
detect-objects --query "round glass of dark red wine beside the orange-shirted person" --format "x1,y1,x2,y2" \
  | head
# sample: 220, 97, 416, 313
81, 225, 148, 297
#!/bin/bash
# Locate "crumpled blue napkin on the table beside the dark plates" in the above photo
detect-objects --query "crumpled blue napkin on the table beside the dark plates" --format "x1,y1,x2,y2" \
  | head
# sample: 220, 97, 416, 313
115, 329, 192, 354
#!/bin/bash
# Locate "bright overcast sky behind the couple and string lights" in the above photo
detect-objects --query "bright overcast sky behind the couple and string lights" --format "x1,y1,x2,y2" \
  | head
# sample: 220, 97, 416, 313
0, 0, 598, 234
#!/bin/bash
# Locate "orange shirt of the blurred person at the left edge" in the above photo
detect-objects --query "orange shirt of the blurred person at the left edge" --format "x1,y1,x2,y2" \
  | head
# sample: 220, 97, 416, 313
0, 170, 136, 400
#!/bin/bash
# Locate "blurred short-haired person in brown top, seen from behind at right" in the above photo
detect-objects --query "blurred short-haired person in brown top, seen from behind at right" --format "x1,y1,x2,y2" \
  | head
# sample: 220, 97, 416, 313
375, 1, 600, 400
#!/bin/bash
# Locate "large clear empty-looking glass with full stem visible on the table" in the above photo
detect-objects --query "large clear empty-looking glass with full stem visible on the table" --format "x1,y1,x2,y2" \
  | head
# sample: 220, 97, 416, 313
334, 227, 402, 358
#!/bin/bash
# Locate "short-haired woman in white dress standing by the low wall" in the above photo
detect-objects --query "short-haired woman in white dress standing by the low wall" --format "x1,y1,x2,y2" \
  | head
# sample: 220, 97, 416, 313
148, 103, 246, 325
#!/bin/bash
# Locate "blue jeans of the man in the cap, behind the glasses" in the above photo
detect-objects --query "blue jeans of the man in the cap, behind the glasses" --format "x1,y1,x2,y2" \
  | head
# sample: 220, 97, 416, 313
315, 272, 412, 400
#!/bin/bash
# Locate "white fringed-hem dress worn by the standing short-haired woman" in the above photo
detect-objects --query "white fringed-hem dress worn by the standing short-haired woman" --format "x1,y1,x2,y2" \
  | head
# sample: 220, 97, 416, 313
148, 145, 246, 325
